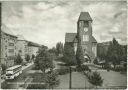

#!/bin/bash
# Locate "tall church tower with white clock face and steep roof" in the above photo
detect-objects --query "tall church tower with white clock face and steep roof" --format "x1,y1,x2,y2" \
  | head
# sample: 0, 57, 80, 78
77, 12, 96, 59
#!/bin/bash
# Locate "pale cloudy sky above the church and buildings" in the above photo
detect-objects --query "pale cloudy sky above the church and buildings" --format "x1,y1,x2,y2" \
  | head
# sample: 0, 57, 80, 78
2, 0, 127, 48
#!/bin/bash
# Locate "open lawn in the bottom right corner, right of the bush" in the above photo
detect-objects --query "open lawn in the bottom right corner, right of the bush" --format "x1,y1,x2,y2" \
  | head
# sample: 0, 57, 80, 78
98, 71, 127, 88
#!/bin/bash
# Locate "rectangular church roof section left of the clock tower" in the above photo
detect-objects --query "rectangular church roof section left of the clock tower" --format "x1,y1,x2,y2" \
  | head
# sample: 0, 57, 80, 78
65, 33, 77, 42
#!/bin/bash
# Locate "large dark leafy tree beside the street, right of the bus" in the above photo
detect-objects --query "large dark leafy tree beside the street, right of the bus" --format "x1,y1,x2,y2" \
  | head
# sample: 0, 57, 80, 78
35, 46, 53, 73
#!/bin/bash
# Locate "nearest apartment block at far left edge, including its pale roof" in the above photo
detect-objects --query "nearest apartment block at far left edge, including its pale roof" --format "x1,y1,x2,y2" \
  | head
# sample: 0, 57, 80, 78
1, 25, 17, 67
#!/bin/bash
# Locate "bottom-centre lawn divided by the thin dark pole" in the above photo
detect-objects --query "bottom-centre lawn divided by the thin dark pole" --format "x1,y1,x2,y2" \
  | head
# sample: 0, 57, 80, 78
55, 72, 93, 89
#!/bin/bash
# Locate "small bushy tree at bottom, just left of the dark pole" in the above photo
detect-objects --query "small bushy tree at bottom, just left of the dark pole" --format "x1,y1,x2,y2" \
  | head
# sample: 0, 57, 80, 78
45, 71, 59, 89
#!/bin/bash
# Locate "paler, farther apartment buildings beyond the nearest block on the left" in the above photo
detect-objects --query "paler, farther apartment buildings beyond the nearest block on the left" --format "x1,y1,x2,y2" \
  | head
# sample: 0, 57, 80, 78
17, 35, 40, 62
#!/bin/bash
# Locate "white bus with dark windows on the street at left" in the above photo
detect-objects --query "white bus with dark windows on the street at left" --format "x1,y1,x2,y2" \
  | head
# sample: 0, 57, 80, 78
6, 65, 22, 79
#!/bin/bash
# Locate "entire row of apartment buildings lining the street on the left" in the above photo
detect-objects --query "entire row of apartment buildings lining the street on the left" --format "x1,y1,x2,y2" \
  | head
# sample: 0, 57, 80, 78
0, 25, 40, 68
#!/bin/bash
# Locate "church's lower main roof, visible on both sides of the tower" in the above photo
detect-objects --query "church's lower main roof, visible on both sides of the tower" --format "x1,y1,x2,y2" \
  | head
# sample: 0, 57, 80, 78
65, 33, 97, 43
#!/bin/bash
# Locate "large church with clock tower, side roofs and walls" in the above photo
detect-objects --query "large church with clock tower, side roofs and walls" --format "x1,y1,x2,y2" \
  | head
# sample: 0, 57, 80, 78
65, 12, 97, 62
